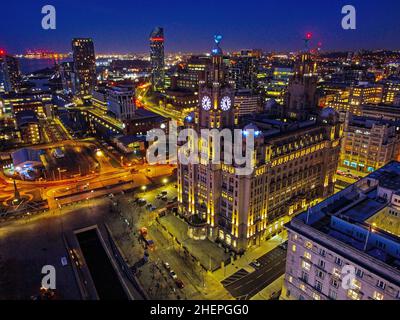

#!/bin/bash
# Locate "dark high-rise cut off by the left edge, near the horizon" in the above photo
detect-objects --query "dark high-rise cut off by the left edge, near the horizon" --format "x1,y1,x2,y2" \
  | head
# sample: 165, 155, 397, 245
0, 54, 22, 92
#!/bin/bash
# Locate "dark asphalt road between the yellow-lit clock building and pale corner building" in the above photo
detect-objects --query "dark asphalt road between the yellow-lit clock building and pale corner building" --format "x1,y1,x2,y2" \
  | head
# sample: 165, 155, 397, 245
225, 247, 286, 300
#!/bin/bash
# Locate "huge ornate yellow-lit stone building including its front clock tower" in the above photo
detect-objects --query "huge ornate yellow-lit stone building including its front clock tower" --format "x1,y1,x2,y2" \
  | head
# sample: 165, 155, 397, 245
178, 37, 342, 252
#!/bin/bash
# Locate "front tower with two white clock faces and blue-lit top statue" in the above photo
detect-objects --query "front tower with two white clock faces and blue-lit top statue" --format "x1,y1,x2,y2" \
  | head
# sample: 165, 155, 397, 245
196, 35, 237, 129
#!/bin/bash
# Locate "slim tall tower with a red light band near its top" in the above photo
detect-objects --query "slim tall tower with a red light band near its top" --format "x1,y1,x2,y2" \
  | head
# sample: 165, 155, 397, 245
150, 27, 165, 91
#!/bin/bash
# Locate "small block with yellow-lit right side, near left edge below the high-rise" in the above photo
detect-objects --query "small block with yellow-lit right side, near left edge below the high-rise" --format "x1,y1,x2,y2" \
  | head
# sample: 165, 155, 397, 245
15, 110, 41, 145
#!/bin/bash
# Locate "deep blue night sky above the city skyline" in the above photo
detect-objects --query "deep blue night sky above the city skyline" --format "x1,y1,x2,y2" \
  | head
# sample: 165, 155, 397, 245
0, 0, 400, 53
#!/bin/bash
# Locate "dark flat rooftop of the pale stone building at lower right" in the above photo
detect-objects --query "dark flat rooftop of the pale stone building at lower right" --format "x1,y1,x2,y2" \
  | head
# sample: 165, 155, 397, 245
288, 162, 400, 270
